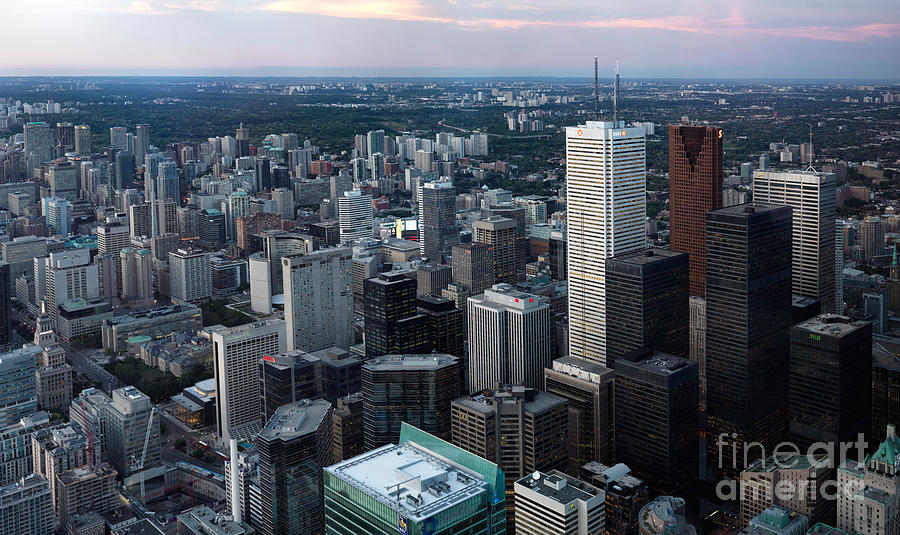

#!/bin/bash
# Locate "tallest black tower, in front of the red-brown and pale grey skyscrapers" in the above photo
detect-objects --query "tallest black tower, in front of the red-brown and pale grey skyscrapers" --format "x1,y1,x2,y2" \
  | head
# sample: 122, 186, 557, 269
706, 204, 791, 479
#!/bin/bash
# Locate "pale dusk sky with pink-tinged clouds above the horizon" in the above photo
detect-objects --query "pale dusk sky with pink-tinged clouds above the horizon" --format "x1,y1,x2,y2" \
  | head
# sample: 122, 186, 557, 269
0, 0, 900, 80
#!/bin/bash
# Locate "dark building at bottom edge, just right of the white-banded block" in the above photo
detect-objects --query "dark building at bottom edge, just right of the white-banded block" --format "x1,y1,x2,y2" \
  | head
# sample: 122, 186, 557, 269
580, 462, 650, 535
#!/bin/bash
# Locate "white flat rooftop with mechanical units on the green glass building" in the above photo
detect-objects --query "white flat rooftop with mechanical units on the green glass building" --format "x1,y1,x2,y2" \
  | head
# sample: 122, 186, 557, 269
325, 443, 488, 523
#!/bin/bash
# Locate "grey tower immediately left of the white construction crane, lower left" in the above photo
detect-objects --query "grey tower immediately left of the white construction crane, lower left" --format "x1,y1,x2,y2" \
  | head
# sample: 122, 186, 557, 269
106, 386, 162, 477
